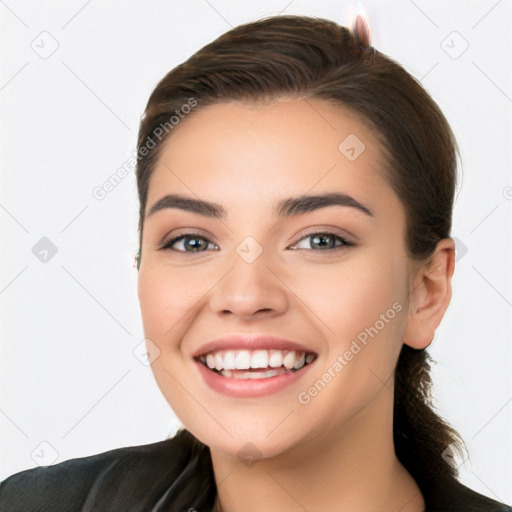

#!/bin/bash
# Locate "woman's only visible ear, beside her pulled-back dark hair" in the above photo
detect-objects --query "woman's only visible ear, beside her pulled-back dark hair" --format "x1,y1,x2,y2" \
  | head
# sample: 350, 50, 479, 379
404, 238, 455, 349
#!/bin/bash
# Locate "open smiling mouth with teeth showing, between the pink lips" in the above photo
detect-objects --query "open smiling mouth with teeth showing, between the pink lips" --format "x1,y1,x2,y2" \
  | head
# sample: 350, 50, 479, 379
195, 350, 317, 379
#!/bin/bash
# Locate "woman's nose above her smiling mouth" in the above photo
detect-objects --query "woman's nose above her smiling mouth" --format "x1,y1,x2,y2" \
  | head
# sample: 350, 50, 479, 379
209, 248, 289, 320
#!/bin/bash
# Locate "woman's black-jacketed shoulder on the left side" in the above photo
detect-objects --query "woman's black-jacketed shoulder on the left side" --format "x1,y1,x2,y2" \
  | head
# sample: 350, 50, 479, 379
0, 435, 199, 512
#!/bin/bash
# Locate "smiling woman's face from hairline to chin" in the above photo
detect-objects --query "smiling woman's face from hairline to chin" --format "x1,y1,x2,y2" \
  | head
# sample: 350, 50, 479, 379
138, 99, 412, 457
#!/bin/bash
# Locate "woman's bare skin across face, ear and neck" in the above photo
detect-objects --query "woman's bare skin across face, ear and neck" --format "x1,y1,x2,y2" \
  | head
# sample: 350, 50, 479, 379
138, 99, 455, 512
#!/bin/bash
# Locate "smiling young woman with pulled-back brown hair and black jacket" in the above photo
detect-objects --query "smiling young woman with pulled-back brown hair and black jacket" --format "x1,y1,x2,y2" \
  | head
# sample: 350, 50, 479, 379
0, 16, 512, 512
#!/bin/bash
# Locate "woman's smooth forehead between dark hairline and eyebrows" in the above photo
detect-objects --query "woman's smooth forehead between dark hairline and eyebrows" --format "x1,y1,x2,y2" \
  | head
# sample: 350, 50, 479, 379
146, 99, 398, 221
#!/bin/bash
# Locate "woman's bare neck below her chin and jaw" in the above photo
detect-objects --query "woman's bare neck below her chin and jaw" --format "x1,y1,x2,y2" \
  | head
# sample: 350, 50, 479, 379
210, 388, 425, 512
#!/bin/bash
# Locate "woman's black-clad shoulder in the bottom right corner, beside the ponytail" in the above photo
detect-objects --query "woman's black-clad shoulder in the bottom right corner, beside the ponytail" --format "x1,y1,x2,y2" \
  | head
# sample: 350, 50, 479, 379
425, 480, 512, 512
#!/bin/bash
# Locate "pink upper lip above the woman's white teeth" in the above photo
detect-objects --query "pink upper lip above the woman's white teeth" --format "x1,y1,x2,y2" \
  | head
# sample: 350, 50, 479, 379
192, 334, 316, 358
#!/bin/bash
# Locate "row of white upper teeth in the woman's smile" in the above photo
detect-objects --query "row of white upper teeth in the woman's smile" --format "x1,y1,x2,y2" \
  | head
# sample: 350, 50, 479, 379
201, 350, 315, 371
